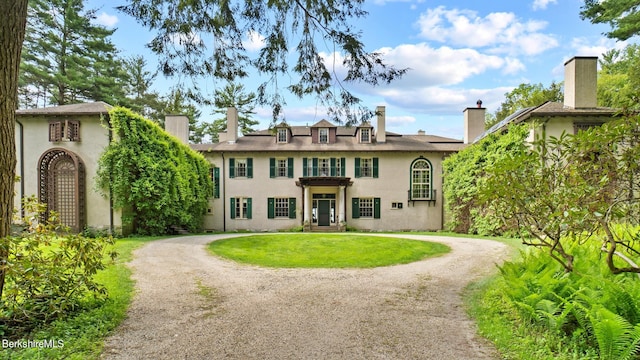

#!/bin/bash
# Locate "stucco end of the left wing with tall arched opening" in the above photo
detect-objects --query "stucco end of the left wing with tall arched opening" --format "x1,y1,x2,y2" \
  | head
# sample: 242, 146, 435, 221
14, 102, 122, 231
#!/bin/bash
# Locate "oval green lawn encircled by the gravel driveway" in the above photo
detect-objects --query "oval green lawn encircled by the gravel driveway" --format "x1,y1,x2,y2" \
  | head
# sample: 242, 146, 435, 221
208, 233, 451, 268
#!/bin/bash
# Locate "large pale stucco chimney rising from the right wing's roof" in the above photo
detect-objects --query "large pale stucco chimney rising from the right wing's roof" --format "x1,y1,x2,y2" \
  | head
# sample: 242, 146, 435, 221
564, 56, 598, 109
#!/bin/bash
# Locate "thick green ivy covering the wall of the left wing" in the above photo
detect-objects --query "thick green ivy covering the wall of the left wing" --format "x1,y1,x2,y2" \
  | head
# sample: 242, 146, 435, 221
97, 107, 213, 235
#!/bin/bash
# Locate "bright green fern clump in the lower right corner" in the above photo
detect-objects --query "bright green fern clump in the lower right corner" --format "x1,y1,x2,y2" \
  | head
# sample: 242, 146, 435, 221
480, 241, 640, 359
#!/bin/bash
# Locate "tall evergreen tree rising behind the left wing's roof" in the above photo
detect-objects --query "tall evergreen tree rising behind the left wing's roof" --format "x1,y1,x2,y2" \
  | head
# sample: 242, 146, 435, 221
19, 0, 126, 107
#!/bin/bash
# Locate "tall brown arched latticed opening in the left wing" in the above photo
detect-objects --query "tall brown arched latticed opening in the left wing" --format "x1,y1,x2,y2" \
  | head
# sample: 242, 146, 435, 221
38, 148, 86, 232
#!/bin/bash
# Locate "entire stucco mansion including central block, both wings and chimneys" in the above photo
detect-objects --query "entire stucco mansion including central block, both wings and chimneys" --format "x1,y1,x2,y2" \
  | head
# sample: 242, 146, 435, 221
14, 57, 616, 231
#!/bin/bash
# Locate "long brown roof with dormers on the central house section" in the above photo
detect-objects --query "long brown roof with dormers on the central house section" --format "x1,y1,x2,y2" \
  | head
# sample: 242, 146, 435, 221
191, 123, 466, 152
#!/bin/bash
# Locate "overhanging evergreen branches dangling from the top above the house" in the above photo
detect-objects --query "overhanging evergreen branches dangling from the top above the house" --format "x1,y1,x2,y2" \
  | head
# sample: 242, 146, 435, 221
119, 0, 407, 123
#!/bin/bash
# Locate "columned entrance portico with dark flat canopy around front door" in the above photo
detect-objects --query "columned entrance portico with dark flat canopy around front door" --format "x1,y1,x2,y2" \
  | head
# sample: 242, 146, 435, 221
296, 176, 353, 231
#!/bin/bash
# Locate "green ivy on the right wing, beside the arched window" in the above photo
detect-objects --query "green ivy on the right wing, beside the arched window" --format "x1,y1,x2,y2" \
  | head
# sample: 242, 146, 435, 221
443, 125, 529, 235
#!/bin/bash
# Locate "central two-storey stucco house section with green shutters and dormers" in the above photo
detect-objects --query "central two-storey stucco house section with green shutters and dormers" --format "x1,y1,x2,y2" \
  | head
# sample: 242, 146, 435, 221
192, 107, 464, 231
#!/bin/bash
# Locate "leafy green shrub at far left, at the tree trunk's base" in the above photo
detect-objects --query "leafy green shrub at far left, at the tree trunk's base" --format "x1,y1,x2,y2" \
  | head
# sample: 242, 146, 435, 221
0, 199, 115, 338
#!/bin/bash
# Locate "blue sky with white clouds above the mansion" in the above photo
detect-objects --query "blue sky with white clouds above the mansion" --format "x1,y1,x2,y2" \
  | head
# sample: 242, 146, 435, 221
86, 0, 626, 138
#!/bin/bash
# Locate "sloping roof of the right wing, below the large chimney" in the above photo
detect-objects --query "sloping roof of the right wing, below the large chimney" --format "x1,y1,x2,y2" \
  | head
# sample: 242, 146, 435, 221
474, 101, 619, 142
